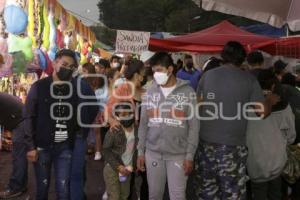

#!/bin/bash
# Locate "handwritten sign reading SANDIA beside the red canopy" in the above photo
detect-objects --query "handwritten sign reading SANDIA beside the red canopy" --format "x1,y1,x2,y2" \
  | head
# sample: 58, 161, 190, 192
116, 30, 150, 54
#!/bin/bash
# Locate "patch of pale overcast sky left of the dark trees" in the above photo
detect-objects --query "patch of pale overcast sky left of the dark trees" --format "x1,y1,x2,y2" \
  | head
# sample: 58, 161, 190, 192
58, 0, 99, 26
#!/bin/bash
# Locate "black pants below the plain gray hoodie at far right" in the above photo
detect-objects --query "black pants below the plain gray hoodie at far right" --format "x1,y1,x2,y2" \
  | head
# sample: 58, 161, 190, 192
251, 176, 283, 200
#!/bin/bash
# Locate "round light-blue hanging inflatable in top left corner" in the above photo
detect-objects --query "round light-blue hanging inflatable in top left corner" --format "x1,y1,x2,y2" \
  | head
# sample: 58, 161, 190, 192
4, 5, 28, 35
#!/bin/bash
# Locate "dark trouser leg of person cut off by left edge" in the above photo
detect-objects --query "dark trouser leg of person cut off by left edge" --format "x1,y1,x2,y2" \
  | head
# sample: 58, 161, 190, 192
8, 123, 28, 192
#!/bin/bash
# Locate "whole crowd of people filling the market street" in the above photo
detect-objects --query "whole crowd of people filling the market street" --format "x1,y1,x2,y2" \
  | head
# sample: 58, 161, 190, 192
0, 41, 300, 200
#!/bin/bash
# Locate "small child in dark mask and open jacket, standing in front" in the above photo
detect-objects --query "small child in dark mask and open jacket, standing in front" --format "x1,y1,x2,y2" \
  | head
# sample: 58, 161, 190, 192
103, 102, 137, 200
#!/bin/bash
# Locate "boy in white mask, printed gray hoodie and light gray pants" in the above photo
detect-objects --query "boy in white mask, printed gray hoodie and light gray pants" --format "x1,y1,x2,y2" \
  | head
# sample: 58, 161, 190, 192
137, 52, 199, 200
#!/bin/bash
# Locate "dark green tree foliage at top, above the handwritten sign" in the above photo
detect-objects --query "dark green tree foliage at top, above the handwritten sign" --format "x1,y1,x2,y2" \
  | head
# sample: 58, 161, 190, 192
98, 0, 201, 32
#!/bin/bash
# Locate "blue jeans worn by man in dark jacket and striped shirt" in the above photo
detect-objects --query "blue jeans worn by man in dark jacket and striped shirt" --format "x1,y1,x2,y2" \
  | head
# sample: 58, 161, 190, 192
34, 142, 72, 200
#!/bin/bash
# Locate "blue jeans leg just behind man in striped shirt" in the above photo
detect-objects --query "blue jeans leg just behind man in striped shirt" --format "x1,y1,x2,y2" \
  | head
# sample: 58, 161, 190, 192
71, 135, 87, 200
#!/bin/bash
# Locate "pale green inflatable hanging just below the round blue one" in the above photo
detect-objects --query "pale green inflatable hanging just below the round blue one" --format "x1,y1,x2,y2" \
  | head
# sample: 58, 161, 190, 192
7, 34, 33, 62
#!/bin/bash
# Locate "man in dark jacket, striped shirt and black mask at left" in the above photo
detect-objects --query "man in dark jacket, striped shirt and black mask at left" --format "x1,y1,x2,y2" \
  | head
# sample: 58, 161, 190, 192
24, 49, 79, 200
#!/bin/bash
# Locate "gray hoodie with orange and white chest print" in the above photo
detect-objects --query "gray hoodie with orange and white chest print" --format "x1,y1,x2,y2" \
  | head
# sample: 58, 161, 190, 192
137, 79, 200, 160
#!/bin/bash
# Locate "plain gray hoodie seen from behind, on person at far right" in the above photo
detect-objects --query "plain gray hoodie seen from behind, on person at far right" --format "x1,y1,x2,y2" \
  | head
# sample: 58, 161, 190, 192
247, 106, 296, 182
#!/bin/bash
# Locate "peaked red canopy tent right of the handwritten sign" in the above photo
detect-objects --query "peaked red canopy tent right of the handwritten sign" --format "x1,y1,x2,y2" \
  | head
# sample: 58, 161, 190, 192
149, 21, 276, 53
